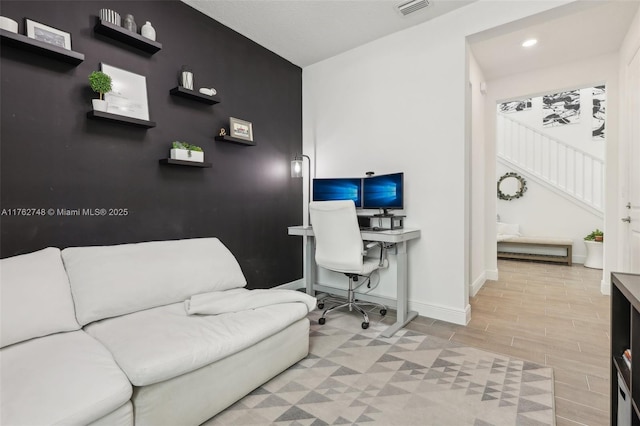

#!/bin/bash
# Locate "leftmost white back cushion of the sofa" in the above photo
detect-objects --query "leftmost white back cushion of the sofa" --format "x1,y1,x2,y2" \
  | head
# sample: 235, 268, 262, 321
0, 247, 80, 347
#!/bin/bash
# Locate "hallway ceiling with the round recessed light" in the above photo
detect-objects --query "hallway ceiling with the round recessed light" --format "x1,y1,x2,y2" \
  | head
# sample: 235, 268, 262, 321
469, 0, 640, 80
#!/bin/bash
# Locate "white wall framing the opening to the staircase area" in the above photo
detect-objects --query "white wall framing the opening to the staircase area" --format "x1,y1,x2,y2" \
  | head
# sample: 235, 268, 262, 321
485, 50, 619, 290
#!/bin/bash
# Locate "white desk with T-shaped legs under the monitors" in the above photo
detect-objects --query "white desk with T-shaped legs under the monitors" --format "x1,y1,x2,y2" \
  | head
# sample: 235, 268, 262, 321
289, 226, 420, 337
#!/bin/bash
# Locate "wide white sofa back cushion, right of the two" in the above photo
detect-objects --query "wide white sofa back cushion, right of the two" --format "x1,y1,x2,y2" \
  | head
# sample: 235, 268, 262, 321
62, 238, 247, 325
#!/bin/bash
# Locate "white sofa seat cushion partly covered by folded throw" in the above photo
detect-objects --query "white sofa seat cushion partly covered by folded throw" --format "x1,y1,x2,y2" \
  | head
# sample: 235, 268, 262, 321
85, 303, 308, 386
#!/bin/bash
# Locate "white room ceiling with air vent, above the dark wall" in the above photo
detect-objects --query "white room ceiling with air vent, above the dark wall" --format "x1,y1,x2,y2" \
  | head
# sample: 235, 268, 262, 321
182, 0, 475, 67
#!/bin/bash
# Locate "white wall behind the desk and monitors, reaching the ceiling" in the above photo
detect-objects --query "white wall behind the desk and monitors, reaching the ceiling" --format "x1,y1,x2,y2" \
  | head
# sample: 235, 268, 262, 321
303, 0, 568, 324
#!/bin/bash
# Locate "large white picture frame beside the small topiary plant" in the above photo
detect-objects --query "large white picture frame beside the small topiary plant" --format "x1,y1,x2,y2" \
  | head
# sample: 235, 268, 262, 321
100, 62, 149, 121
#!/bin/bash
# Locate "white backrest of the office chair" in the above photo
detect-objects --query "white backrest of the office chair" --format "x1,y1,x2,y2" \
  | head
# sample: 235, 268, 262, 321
309, 200, 364, 273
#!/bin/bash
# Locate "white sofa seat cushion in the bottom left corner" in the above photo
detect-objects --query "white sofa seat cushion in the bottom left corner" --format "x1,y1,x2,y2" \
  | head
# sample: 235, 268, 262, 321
0, 331, 132, 426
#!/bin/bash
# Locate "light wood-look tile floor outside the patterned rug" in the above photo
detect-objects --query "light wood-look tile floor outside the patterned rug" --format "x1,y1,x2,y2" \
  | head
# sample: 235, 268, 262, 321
407, 260, 610, 426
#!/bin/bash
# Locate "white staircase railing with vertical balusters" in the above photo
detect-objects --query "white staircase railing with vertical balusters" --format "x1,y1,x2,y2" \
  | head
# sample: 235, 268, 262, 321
496, 114, 604, 217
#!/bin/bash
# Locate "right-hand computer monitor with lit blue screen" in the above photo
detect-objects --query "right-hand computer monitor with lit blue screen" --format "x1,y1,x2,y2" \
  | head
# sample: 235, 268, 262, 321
362, 173, 404, 215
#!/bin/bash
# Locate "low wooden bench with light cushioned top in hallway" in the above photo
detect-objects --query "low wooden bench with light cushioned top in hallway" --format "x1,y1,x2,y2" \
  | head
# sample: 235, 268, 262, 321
498, 237, 573, 266
